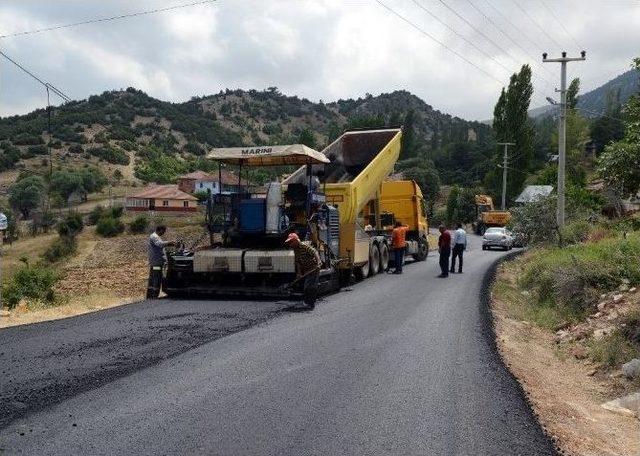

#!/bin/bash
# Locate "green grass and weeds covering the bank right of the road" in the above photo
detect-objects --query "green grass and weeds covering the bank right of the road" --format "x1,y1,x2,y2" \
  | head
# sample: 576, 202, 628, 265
493, 232, 640, 369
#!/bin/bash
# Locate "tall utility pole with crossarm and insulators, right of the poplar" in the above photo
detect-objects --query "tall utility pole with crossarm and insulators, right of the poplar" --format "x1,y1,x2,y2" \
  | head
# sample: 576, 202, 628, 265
542, 51, 587, 228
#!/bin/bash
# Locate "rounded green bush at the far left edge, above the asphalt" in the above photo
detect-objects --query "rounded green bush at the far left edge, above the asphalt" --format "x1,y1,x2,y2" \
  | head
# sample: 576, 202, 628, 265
3, 264, 58, 309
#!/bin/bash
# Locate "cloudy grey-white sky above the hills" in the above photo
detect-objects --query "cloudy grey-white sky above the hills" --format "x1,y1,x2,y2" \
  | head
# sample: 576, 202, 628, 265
0, 0, 640, 120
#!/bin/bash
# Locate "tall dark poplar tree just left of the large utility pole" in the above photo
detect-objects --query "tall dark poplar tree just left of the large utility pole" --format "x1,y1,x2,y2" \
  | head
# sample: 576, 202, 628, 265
485, 65, 533, 200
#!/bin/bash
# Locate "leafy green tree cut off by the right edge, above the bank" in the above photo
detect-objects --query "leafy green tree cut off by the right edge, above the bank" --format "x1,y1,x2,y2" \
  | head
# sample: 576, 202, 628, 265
598, 57, 640, 197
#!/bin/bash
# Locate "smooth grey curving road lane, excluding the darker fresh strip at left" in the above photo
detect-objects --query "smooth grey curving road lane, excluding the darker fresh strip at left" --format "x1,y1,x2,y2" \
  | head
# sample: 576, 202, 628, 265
0, 238, 555, 455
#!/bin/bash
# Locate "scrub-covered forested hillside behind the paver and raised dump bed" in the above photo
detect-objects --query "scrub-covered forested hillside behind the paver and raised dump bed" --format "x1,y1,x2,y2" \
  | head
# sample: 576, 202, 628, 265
0, 87, 491, 190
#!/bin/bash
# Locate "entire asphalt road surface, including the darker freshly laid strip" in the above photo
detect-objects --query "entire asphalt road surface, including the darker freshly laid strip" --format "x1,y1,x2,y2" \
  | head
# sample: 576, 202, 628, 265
0, 238, 555, 455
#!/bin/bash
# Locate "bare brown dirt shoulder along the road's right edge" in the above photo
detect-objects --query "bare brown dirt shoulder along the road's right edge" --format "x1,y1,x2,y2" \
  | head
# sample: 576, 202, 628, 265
491, 264, 640, 455
